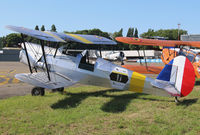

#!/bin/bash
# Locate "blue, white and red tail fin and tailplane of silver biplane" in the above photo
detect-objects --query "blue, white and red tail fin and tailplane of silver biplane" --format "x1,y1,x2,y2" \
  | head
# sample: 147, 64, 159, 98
152, 56, 195, 97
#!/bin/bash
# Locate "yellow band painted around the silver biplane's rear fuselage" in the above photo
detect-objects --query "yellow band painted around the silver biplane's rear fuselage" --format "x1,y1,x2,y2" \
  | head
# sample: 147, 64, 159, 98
129, 72, 146, 93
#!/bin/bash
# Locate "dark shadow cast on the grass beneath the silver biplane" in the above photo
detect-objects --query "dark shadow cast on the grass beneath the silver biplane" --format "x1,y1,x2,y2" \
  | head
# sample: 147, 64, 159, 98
51, 89, 177, 113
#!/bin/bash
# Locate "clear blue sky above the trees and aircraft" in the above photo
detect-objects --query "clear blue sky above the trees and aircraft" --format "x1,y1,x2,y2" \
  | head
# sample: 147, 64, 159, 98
0, 0, 200, 37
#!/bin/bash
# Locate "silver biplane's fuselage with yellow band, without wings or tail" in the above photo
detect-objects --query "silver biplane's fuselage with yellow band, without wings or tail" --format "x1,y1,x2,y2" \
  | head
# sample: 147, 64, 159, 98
20, 44, 174, 96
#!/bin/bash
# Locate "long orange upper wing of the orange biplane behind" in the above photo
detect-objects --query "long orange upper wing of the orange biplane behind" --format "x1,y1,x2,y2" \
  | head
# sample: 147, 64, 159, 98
115, 37, 200, 48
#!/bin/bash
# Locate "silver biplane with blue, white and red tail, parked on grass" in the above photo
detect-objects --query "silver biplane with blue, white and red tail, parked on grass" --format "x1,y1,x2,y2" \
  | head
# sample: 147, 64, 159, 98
7, 26, 195, 101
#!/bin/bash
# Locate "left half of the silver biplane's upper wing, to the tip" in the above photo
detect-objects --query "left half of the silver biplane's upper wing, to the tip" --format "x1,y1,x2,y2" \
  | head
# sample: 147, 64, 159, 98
6, 25, 65, 42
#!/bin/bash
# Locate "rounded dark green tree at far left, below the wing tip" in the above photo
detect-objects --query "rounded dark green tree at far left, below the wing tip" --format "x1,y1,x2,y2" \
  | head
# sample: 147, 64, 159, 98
5, 33, 21, 47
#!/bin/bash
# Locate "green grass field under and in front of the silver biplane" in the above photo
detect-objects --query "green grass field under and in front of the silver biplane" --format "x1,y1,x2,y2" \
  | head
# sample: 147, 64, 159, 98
0, 86, 200, 135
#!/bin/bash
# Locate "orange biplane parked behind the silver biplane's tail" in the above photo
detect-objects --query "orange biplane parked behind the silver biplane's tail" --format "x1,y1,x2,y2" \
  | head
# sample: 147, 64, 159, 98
116, 37, 200, 78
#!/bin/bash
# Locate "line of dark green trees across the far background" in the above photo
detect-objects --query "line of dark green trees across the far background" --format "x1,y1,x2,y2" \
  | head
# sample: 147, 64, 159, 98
0, 24, 187, 50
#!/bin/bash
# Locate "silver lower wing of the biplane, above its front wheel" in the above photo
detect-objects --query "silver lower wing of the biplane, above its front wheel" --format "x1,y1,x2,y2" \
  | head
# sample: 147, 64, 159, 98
15, 72, 77, 89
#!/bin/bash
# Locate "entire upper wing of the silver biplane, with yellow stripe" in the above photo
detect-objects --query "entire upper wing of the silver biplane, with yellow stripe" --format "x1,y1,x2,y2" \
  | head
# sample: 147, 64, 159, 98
6, 25, 117, 45
